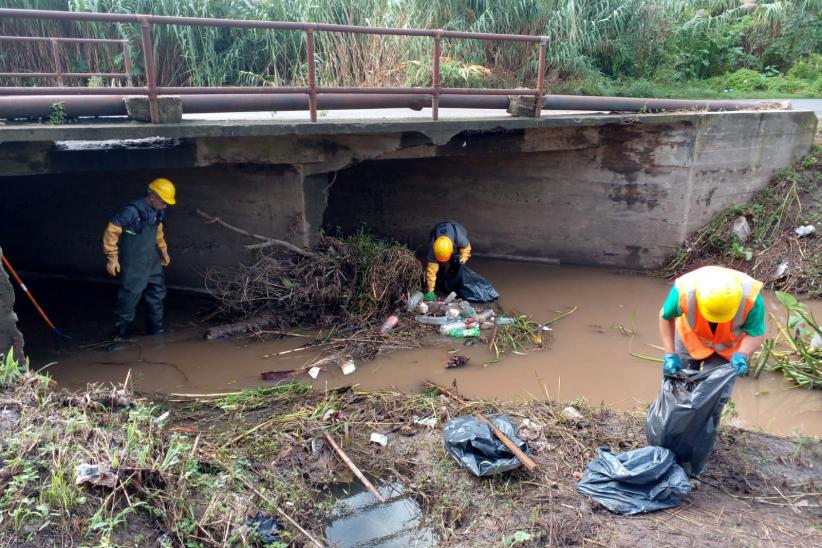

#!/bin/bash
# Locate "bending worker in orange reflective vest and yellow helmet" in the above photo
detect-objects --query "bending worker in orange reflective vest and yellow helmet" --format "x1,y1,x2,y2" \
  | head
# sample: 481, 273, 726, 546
659, 266, 765, 386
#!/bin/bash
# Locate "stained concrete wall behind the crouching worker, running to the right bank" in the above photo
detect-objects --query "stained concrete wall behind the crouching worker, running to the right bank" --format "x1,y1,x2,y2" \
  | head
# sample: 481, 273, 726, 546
326, 112, 815, 268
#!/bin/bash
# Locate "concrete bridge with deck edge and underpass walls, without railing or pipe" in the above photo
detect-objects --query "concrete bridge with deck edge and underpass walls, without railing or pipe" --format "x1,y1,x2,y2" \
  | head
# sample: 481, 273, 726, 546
0, 110, 817, 354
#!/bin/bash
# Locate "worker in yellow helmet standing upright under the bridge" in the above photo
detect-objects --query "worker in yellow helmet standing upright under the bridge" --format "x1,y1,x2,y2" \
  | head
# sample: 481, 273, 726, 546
103, 179, 176, 340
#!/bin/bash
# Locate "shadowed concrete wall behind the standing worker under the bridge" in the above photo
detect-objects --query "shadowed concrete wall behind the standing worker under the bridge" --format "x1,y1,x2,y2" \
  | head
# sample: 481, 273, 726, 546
0, 165, 308, 287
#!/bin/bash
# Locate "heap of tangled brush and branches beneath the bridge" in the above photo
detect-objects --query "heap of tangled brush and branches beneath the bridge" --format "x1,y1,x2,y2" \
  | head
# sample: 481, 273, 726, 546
205, 232, 422, 329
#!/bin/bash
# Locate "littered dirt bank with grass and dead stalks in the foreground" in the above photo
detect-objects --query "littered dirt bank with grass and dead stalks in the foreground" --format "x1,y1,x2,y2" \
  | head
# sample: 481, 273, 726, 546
0, 370, 822, 547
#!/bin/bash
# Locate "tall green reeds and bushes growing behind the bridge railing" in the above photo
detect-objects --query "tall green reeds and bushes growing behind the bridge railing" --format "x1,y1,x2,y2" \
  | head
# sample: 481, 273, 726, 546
0, 0, 822, 98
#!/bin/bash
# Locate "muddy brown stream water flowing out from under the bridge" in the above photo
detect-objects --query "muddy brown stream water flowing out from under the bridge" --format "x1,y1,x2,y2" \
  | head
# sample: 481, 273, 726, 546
20, 260, 822, 436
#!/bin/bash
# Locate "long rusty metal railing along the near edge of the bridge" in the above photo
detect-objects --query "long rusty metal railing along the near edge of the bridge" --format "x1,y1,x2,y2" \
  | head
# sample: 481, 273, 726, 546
0, 9, 548, 123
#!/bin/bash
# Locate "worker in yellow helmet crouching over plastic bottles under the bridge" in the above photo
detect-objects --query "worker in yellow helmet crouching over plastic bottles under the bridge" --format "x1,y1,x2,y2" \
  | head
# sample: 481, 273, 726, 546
424, 221, 471, 302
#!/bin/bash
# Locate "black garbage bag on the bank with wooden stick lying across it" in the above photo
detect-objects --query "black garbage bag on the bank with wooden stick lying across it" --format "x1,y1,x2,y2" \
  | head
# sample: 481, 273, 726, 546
443, 415, 528, 476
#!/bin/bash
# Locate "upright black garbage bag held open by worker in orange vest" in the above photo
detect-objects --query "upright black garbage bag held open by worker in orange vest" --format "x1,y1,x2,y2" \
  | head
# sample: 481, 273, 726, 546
645, 364, 736, 476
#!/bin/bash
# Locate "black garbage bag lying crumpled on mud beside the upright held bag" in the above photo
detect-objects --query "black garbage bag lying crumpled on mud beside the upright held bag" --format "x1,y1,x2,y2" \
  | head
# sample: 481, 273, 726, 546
577, 447, 691, 516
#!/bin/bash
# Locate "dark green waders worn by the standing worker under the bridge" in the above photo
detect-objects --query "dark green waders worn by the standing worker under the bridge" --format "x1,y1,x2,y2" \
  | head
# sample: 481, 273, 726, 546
114, 225, 166, 337
